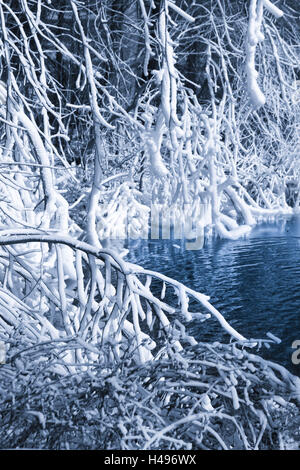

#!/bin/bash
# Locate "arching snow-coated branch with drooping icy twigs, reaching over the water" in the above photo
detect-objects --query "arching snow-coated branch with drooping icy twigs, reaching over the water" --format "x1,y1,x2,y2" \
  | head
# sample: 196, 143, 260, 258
0, 229, 253, 370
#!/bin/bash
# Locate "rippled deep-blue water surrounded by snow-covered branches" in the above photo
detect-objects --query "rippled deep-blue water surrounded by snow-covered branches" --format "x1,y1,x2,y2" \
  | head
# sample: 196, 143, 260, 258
126, 217, 300, 375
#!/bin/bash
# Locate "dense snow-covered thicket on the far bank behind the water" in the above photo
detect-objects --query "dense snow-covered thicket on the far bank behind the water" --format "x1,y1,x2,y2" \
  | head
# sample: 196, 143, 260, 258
1, 0, 299, 243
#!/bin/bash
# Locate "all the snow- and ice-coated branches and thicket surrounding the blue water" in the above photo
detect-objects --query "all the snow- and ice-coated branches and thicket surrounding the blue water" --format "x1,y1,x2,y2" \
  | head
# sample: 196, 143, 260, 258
0, 0, 300, 450
